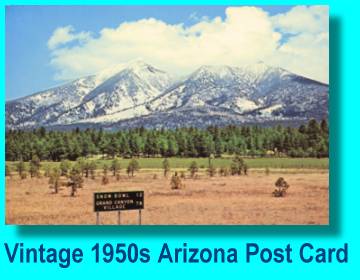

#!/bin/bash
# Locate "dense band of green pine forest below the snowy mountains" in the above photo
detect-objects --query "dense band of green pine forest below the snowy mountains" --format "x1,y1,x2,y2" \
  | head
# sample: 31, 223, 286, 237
6, 120, 329, 161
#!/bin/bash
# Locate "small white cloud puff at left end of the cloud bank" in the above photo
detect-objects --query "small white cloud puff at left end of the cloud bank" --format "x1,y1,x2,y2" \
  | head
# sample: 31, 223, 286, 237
47, 25, 90, 49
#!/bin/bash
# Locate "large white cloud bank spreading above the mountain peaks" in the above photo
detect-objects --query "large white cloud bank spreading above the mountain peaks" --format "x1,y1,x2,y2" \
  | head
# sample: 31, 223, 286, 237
48, 6, 328, 82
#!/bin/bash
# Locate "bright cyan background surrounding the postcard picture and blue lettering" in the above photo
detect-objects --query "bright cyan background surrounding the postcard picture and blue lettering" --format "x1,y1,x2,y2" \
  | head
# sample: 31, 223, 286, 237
0, 0, 360, 279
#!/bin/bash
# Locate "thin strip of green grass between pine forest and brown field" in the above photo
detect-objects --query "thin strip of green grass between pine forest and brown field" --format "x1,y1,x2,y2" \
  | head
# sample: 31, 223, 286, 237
6, 157, 329, 171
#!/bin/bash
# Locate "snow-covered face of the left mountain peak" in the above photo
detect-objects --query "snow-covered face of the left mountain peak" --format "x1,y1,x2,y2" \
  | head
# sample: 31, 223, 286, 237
53, 61, 171, 123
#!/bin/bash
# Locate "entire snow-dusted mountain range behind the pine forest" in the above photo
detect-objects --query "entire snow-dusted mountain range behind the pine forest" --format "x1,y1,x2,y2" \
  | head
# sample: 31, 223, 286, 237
6, 61, 328, 129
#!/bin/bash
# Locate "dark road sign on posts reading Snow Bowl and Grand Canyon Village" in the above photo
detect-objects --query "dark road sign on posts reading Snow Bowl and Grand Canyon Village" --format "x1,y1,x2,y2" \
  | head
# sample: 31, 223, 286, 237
94, 191, 144, 225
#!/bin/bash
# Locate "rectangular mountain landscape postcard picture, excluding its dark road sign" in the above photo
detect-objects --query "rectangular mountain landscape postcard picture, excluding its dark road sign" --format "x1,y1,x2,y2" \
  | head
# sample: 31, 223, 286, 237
5, 6, 329, 225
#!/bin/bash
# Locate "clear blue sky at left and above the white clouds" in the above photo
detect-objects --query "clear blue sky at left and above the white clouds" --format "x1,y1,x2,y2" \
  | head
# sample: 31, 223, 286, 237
6, 6, 318, 100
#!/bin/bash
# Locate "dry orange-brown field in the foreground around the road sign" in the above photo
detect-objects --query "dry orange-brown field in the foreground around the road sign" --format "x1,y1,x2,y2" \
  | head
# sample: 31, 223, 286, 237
6, 170, 329, 225
